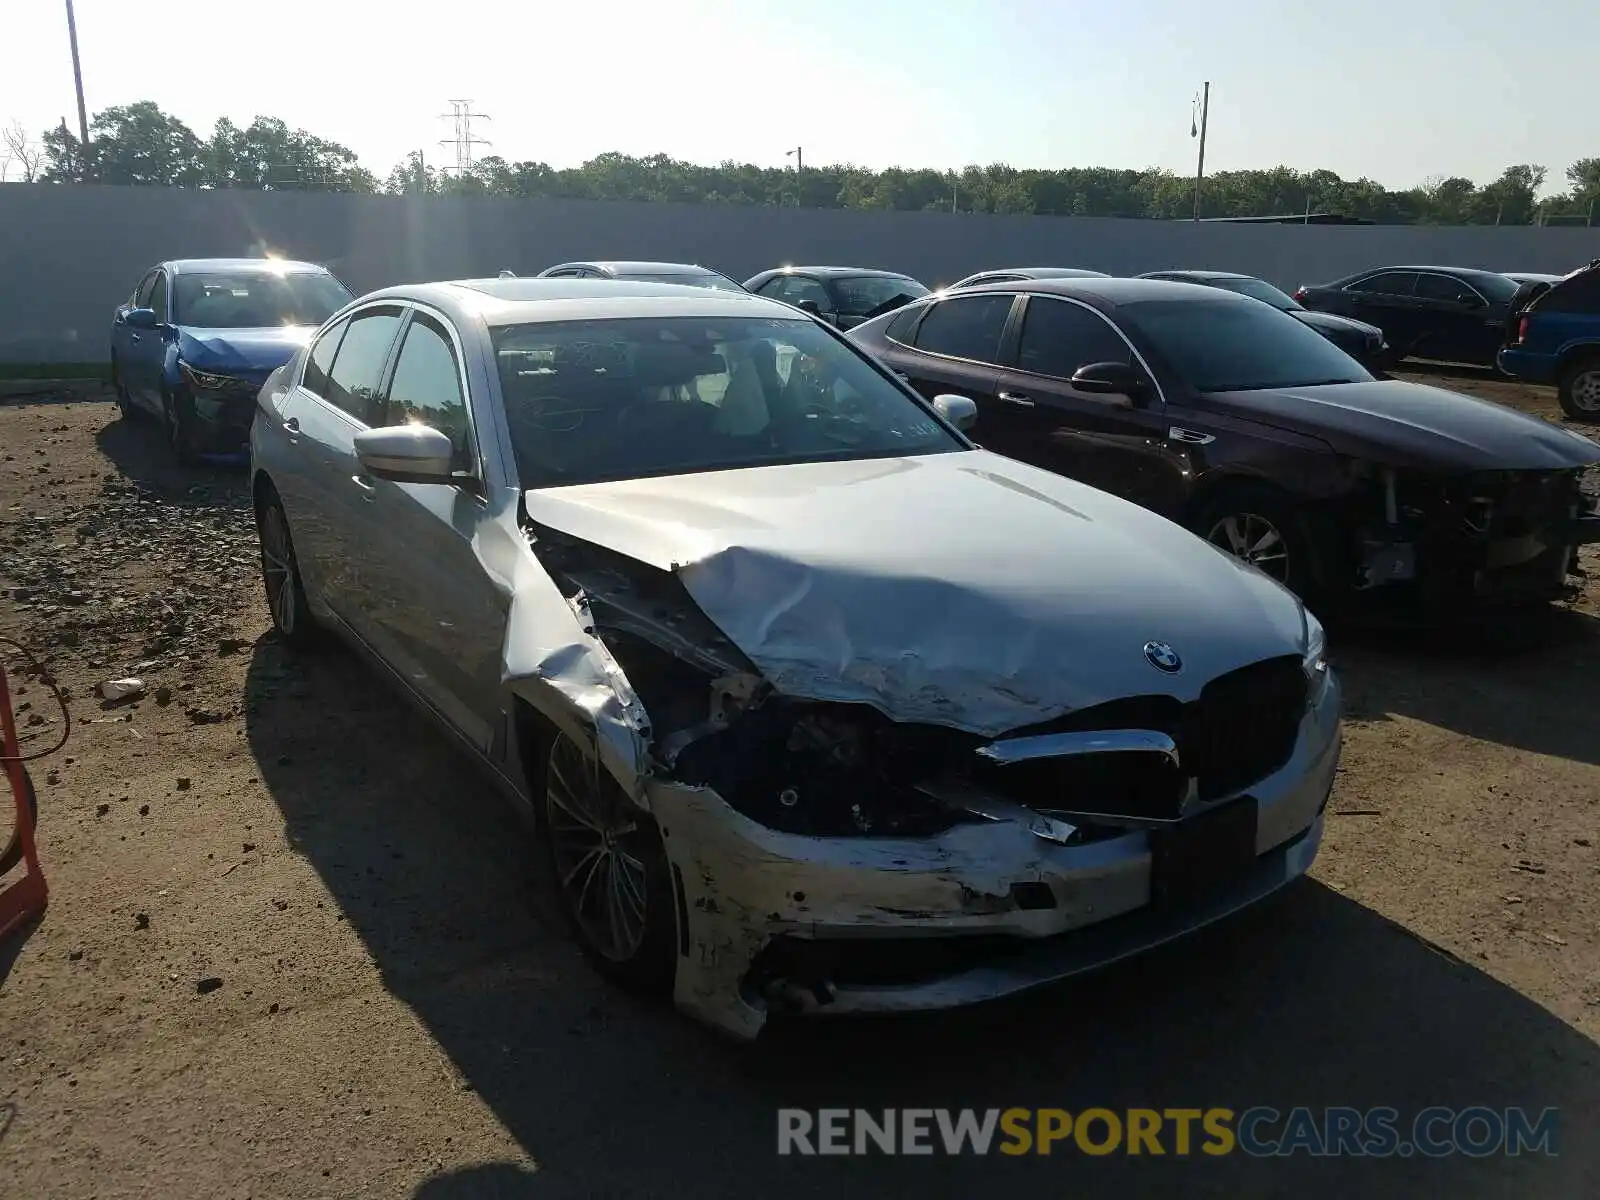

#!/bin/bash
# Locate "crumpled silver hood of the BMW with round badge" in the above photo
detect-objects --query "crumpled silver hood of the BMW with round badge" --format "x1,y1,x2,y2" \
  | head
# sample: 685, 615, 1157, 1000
525, 451, 1306, 736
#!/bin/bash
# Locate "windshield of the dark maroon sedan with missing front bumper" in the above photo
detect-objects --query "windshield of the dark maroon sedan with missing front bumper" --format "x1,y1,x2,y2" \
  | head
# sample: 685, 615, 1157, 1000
1117, 296, 1373, 392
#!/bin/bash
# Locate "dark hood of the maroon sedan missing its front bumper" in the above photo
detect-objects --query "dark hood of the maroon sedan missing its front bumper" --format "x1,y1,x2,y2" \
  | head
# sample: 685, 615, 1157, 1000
1205, 379, 1600, 470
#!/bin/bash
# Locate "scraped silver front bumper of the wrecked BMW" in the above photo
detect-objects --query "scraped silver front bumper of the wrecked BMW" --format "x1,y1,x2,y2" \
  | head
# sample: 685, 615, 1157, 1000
646, 674, 1341, 1038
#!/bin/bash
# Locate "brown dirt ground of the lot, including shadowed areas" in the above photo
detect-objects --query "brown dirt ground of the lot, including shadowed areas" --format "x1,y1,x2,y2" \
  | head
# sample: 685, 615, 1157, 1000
0, 376, 1600, 1200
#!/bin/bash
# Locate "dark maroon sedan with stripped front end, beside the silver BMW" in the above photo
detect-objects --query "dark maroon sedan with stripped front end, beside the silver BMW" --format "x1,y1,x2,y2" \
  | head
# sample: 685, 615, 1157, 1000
848, 278, 1600, 608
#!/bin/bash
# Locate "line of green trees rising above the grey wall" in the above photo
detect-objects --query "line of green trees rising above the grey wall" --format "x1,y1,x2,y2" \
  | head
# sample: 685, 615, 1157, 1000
12, 101, 1600, 226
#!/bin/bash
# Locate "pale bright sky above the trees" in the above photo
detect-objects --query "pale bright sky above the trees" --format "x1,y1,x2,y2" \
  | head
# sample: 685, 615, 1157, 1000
0, 0, 1600, 190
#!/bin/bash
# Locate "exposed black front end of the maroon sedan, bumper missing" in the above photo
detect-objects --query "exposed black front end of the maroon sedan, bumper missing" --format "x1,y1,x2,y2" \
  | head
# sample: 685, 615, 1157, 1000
1346, 462, 1600, 610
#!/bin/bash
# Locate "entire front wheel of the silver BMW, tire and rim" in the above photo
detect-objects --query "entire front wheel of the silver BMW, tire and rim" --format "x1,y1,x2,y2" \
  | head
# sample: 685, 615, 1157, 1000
541, 734, 677, 994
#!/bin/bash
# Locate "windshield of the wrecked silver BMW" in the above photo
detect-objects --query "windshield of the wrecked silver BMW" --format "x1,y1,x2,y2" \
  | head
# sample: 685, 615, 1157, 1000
493, 317, 966, 488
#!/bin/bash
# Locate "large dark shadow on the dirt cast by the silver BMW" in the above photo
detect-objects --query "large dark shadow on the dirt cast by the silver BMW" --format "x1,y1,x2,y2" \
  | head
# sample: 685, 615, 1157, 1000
248, 638, 1600, 1200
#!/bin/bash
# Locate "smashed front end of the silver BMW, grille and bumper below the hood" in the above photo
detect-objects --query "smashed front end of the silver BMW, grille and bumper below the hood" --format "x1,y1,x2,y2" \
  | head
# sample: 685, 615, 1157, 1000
530, 530, 1339, 1037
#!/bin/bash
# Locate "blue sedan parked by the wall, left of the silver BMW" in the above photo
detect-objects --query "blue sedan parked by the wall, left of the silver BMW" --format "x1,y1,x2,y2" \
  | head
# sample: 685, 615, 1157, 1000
110, 258, 354, 462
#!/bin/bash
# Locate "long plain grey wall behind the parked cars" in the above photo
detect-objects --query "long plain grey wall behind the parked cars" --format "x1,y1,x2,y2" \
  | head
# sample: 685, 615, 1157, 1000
0, 184, 1600, 363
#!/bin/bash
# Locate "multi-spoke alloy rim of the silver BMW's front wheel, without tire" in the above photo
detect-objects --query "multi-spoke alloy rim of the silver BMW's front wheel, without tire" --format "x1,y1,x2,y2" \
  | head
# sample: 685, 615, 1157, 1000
546, 738, 650, 963
